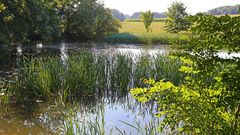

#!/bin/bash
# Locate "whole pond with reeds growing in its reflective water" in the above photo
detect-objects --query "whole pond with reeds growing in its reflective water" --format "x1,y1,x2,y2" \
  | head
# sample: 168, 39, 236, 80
0, 43, 239, 135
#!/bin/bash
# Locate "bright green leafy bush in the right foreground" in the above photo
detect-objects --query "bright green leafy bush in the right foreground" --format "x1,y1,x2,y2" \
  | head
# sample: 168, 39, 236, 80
131, 14, 240, 135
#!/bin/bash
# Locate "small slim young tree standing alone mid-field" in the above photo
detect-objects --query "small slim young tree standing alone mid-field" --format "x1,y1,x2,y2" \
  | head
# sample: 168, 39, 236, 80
141, 11, 153, 32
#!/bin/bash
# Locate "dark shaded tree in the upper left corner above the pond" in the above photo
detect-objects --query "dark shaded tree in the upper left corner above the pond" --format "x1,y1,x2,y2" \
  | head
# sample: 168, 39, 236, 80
0, 0, 60, 42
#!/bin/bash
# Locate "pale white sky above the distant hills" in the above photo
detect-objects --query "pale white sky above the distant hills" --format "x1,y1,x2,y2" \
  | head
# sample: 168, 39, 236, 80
101, 0, 240, 15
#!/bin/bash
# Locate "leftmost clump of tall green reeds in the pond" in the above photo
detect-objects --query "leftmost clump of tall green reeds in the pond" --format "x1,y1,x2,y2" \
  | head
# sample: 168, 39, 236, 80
11, 56, 63, 101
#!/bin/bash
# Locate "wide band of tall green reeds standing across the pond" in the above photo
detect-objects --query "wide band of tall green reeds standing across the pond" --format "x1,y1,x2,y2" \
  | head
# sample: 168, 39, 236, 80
8, 51, 182, 101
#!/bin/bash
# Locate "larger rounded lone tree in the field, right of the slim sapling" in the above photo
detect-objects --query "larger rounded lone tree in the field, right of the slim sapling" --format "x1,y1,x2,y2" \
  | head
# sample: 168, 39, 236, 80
166, 2, 190, 33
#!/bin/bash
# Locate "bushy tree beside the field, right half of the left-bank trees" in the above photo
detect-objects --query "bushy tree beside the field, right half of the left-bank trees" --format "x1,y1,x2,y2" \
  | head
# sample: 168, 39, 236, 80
52, 0, 120, 40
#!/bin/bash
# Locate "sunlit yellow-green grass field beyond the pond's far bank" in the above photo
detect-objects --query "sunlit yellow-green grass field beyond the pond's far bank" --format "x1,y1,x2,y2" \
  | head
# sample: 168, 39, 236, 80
105, 22, 187, 45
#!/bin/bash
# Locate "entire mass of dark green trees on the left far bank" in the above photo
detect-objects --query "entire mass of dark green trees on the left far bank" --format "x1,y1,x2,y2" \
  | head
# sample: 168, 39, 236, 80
0, 0, 120, 43
